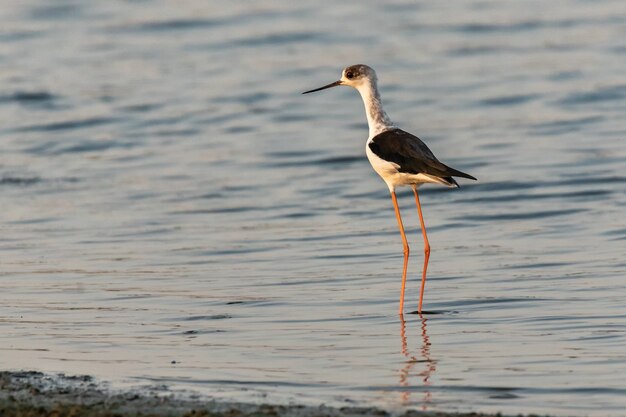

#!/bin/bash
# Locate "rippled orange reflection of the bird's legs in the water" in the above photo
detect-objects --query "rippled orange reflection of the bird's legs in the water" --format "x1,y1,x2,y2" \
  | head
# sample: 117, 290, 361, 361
400, 314, 437, 411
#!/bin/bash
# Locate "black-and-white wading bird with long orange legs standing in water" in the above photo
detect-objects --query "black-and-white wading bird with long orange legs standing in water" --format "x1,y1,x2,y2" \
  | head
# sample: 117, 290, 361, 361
302, 65, 476, 314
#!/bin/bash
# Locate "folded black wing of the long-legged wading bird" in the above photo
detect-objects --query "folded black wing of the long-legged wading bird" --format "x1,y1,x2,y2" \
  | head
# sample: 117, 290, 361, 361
369, 129, 476, 181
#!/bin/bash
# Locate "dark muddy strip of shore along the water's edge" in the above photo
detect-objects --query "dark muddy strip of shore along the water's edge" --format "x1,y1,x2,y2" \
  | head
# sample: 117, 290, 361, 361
0, 371, 528, 417
